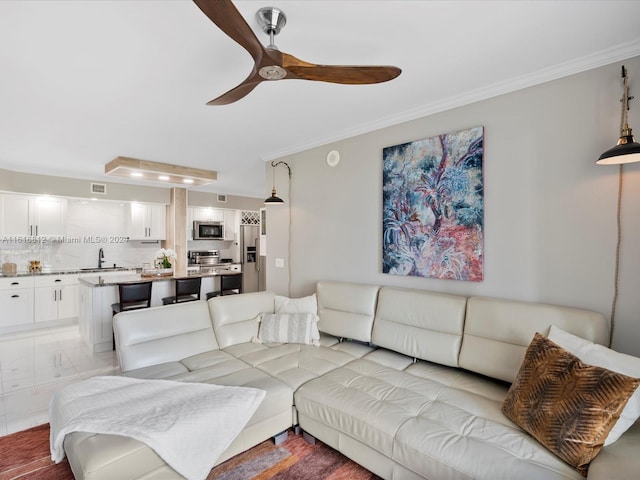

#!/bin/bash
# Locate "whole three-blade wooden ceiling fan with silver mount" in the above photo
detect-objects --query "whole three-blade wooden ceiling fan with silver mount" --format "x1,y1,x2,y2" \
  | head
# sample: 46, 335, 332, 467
193, 0, 401, 105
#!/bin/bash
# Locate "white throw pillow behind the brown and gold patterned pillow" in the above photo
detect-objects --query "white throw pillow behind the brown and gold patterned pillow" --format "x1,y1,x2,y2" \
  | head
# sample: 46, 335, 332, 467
548, 325, 640, 447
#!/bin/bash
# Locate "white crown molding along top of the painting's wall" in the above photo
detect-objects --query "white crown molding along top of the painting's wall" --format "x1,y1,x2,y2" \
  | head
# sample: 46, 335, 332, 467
261, 40, 640, 162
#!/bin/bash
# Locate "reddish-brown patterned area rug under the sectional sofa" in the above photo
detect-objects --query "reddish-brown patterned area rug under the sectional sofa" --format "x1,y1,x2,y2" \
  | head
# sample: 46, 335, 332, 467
0, 424, 379, 480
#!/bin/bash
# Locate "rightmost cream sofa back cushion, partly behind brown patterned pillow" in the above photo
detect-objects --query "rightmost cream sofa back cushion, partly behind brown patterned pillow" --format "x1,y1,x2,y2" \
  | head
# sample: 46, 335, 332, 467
460, 297, 608, 382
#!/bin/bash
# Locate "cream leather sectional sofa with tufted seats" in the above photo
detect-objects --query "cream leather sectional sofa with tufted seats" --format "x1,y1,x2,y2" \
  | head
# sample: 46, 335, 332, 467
65, 282, 640, 480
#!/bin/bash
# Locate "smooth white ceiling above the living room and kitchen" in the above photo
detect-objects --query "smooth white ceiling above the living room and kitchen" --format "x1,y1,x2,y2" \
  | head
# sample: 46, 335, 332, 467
0, 0, 640, 197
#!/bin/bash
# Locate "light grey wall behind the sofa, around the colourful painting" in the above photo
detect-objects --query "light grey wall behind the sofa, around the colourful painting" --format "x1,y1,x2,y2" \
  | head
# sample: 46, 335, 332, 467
265, 57, 640, 355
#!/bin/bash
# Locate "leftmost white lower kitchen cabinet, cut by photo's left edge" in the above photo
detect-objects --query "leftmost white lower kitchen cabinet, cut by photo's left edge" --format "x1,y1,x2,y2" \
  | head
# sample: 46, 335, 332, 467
0, 277, 33, 328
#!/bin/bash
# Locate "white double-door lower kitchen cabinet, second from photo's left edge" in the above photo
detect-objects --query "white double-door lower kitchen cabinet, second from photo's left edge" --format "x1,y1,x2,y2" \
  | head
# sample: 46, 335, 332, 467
34, 275, 78, 323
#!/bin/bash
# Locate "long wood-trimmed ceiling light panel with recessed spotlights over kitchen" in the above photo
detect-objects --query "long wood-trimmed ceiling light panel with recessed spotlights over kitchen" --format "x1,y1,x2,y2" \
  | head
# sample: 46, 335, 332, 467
104, 157, 218, 186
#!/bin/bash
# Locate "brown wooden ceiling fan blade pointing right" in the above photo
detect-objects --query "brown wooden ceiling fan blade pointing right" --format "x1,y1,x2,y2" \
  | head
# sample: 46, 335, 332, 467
282, 52, 402, 85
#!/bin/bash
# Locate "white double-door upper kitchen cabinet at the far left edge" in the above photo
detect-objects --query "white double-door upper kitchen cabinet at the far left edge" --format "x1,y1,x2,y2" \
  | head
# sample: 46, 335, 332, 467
0, 194, 67, 237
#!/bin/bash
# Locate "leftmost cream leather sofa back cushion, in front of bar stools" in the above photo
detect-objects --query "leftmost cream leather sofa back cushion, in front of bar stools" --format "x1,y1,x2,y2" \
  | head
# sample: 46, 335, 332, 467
113, 301, 218, 372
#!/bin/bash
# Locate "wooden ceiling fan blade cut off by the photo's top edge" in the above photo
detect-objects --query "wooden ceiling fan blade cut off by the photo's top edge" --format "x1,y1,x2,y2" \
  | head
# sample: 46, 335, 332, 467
193, 0, 265, 62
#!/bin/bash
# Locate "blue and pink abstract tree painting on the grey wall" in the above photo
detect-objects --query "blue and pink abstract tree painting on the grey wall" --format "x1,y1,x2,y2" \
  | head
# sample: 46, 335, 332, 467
382, 127, 484, 282
